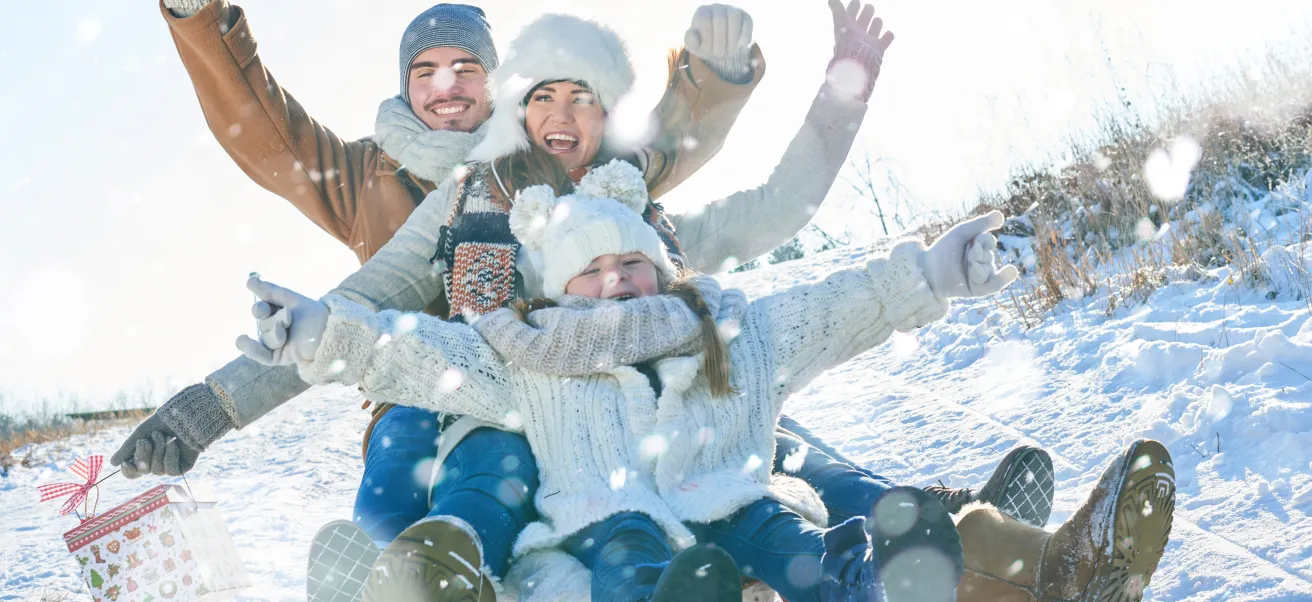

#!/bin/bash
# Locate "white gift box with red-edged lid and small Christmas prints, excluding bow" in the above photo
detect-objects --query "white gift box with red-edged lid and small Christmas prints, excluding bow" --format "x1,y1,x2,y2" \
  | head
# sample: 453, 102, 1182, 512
64, 485, 251, 602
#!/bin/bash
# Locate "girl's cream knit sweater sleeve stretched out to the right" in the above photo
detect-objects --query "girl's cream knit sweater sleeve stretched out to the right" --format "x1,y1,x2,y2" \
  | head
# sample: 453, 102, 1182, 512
731, 241, 947, 401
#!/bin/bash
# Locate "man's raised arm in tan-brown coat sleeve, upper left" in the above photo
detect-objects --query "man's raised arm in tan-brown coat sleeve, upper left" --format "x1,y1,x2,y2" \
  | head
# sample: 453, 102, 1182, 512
160, 0, 379, 243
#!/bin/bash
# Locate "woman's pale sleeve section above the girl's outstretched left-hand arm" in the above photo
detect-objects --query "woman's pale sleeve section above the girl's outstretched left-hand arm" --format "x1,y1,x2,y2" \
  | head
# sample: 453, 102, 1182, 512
331, 177, 459, 311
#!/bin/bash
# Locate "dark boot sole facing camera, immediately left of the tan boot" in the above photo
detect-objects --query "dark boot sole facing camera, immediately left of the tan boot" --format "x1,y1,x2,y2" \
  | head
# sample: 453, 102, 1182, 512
869, 487, 963, 602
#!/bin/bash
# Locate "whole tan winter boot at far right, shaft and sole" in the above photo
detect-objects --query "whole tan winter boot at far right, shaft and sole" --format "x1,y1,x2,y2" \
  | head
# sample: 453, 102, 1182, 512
956, 441, 1176, 602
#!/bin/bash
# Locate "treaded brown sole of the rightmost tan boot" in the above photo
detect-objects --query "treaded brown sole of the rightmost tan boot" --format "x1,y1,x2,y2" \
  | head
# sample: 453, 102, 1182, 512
1084, 441, 1176, 602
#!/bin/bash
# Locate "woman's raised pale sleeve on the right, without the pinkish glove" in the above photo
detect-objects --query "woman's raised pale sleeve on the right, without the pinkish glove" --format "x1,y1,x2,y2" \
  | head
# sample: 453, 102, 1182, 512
669, 84, 866, 274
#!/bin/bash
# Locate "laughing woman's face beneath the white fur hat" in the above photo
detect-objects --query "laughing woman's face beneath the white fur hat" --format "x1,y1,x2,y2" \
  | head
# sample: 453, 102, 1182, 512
523, 81, 606, 171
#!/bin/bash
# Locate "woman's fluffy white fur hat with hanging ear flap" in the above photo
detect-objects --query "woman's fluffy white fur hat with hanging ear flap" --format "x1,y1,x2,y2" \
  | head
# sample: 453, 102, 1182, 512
470, 14, 634, 161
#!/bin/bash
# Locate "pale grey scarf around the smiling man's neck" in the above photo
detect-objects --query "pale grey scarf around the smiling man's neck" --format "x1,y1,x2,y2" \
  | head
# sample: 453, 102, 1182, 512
374, 96, 484, 184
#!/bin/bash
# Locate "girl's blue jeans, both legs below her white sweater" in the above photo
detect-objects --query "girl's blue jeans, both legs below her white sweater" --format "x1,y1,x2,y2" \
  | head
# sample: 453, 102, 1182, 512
562, 500, 824, 602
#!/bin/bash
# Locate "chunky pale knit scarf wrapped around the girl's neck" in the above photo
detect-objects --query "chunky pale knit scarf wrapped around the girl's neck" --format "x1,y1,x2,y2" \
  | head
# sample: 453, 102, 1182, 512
474, 277, 722, 376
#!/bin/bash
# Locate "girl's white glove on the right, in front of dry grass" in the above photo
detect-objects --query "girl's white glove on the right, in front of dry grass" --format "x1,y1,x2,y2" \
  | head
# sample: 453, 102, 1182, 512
920, 211, 1019, 299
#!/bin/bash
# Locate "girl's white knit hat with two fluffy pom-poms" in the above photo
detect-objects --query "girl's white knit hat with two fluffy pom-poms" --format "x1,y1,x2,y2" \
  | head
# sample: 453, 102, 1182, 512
510, 159, 677, 299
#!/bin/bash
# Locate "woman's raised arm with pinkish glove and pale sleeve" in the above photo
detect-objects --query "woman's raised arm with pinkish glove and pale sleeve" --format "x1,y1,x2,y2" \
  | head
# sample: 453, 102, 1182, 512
669, 3, 893, 274
